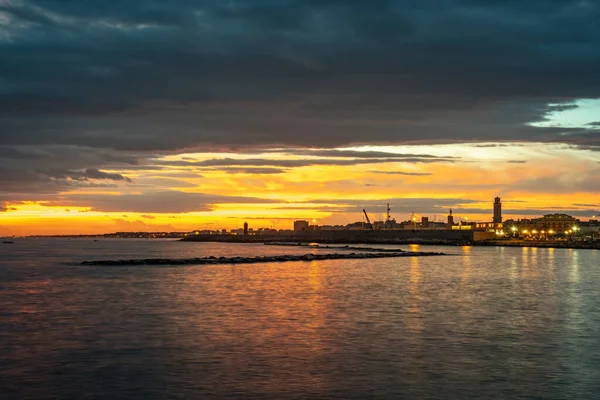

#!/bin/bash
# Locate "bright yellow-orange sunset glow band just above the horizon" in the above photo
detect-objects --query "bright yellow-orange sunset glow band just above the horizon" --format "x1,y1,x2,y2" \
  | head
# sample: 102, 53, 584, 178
0, 144, 600, 236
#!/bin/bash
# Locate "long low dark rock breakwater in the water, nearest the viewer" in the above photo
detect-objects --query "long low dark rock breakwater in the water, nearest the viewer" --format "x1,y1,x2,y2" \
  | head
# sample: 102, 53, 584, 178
81, 251, 445, 266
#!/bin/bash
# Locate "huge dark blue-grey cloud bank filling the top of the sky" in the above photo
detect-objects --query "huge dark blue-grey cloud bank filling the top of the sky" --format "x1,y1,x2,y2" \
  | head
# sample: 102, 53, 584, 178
0, 0, 600, 153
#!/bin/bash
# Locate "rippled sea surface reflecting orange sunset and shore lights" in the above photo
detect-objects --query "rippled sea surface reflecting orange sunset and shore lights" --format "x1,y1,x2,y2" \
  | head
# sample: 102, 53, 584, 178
0, 239, 600, 399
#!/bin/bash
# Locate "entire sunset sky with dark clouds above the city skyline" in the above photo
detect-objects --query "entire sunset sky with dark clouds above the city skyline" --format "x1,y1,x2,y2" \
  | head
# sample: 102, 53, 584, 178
0, 0, 600, 236
